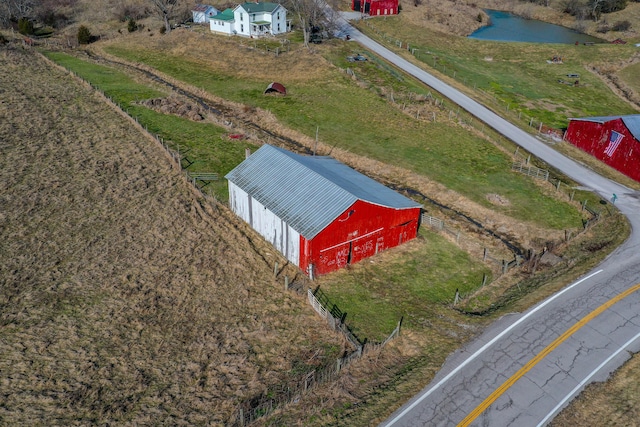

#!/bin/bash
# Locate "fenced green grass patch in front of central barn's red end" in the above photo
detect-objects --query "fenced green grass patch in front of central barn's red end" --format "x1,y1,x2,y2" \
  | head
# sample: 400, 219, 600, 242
317, 230, 492, 340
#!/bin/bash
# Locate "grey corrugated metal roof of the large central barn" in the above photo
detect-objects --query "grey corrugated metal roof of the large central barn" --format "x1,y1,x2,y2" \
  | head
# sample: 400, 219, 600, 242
225, 145, 421, 239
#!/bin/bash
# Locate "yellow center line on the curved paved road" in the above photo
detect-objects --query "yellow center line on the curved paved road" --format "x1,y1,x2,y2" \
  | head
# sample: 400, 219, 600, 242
458, 283, 640, 427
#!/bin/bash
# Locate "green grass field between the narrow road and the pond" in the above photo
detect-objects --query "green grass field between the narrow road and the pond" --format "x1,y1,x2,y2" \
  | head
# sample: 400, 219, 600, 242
359, 15, 637, 129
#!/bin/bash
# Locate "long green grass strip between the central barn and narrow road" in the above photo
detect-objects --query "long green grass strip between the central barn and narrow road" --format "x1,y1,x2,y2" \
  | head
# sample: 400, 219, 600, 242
96, 32, 581, 229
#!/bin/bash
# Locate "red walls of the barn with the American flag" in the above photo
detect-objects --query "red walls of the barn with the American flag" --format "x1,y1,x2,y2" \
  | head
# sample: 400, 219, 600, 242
565, 119, 640, 181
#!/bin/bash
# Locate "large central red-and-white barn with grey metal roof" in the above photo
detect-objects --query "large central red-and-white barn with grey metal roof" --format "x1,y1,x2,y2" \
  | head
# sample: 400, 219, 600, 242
226, 145, 421, 278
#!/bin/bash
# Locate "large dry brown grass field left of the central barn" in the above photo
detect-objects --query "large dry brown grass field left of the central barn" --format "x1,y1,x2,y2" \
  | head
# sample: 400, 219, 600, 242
0, 45, 341, 425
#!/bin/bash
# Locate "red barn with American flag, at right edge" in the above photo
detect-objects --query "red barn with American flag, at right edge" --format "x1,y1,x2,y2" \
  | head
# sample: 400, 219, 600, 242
564, 114, 640, 181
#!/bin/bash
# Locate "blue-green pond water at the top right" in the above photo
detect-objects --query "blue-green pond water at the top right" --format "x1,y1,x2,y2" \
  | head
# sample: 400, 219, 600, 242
469, 10, 603, 44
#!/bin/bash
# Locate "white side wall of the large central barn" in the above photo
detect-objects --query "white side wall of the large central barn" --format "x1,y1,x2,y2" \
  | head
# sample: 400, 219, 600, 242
229, 182, 300, 266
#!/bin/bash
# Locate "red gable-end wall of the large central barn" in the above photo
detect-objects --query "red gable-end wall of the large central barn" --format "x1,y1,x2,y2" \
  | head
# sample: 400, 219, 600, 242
300, 201, 420, 275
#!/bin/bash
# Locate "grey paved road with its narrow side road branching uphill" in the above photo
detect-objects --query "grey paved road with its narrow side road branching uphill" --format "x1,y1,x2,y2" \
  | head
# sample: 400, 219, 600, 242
341, 14, 640, 427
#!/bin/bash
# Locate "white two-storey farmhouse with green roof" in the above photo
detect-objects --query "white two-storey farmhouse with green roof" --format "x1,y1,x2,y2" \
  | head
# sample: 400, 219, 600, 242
209, 2, 291, 37
